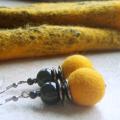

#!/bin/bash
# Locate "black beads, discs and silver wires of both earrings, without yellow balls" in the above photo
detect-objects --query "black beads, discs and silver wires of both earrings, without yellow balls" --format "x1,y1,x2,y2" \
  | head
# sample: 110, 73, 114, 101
0, 66, 71, 105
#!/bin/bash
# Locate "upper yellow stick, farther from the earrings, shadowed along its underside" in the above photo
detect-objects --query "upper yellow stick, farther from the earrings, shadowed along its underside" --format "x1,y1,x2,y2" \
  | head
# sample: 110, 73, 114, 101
0, 0, 120, 29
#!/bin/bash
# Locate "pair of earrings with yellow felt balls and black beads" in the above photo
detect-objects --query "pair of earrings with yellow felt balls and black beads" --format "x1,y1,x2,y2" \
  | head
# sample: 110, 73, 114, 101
0, 55, 105, 106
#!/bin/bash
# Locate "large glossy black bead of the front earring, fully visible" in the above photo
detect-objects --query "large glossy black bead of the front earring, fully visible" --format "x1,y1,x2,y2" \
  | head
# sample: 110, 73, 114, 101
40, 82, 60, 105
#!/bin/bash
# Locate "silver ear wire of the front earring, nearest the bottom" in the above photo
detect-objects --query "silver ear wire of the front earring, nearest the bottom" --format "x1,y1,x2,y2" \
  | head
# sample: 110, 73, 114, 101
0, 91, 30, 105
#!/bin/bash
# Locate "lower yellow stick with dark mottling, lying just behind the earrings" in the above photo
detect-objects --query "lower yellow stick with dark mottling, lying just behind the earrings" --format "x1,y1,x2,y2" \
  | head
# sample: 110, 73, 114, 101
0, 25, 120, 60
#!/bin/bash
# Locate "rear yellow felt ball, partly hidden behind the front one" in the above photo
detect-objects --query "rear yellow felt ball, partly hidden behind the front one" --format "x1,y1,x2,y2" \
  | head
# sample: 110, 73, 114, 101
61, 55, 93, 78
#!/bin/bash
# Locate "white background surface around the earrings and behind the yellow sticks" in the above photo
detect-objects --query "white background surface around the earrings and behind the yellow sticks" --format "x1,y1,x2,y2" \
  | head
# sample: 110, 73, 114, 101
0, 0, 120, 120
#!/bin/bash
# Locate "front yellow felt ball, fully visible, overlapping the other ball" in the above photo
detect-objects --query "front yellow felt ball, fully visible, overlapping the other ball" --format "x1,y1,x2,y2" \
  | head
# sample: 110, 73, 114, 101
68, 68, 105, 106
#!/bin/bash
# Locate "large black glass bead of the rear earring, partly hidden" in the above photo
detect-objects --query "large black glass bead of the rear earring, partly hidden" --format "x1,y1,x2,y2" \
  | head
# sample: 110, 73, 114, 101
37, 69, 53, 86
